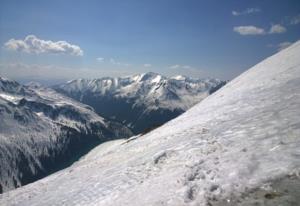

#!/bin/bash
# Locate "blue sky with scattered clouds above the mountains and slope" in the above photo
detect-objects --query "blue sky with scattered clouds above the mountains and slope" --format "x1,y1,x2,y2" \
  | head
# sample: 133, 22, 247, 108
0, 0, 300, 81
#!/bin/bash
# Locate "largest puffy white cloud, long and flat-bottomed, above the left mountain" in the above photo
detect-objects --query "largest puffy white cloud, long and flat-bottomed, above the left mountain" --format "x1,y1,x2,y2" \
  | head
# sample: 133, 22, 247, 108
4, 35, 83, 56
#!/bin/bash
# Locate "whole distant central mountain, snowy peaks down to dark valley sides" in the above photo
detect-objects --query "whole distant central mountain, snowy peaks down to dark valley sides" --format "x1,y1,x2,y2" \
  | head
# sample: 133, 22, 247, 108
54, 72, 226, 133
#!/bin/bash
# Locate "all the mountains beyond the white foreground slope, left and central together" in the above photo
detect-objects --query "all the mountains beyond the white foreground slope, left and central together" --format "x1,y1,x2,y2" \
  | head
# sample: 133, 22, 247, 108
0, 73, 226, 193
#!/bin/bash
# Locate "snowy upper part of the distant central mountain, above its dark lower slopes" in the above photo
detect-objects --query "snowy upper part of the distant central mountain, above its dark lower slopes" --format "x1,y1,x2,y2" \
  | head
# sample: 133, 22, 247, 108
54, 72, 224, 110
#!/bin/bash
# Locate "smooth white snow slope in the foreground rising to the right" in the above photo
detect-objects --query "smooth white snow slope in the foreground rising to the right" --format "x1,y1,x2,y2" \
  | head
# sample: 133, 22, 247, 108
0, 41, 300, 206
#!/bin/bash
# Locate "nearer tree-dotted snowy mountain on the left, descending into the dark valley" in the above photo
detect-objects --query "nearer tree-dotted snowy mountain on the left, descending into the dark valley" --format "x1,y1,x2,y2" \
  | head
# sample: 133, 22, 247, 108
0, 77, 131, 194
